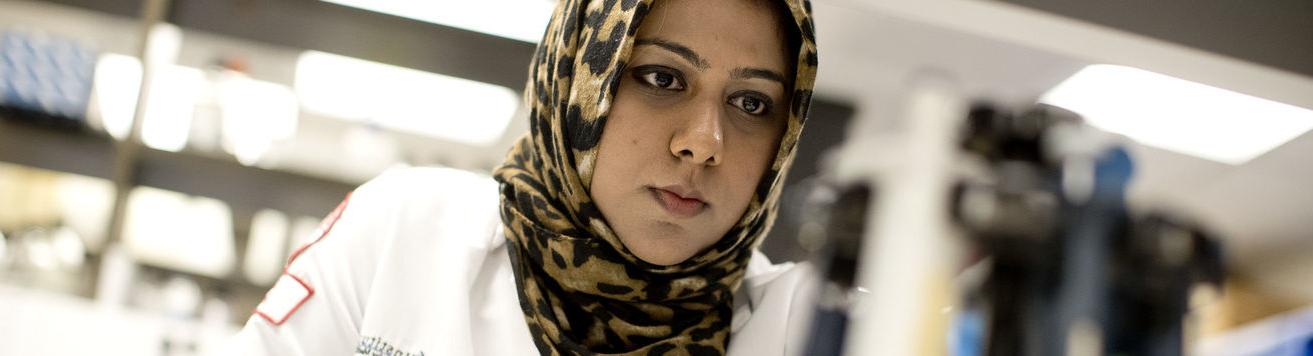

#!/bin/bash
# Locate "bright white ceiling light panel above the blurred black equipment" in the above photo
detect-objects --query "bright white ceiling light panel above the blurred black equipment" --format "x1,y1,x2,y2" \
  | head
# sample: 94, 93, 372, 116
1040, 64, 1313, 164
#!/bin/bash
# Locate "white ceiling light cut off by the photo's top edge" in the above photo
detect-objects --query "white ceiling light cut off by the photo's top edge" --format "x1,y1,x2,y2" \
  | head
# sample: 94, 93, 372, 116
324, 0, 555, 43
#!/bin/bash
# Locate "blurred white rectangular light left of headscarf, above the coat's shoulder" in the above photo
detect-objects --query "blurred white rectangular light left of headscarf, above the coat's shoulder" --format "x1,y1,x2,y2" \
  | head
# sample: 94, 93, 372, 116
294, 51, 520, 146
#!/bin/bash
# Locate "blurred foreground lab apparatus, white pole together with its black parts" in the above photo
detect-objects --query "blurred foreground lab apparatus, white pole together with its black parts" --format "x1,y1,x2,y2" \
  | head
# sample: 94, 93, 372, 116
800, 96, 1224, 355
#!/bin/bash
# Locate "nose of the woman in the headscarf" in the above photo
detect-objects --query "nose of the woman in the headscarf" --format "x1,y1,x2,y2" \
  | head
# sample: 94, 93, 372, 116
670, 101, 725, 166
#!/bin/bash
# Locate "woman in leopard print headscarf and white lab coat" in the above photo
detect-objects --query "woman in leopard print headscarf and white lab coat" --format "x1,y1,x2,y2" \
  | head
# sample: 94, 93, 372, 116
235, 0, 817, 355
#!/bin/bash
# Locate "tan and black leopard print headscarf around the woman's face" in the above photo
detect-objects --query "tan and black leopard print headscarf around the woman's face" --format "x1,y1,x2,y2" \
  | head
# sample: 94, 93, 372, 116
494, 0, 817, 355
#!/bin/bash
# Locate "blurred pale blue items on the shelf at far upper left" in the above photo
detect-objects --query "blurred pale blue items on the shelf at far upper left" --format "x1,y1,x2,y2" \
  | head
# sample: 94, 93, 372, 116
0, 32, 97, 126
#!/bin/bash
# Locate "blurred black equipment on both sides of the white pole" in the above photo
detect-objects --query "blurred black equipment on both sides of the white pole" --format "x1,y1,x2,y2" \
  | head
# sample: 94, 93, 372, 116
802, 104, 1224, 356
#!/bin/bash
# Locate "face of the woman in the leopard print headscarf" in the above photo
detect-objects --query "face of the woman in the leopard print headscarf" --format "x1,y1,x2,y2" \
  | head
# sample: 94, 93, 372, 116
591, 0, 793, 265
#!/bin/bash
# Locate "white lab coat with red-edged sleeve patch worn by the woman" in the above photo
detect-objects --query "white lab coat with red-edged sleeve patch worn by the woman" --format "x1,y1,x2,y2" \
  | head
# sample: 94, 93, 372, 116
227, 168, 815, 356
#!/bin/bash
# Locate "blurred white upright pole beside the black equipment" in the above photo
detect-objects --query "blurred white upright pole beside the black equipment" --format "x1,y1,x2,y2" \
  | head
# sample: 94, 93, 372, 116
844, 74, 966, 355
